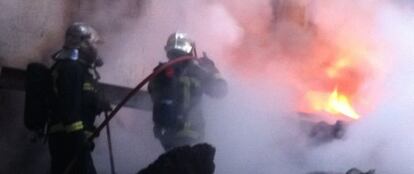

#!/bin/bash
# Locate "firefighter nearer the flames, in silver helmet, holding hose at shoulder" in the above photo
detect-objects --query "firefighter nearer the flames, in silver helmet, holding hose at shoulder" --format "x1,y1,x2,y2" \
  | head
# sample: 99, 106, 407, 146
148, 32, 227, 150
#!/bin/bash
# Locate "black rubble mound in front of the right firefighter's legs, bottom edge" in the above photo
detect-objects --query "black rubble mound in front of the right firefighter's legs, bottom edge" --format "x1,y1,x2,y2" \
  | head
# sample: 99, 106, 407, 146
138, 143, 216, 174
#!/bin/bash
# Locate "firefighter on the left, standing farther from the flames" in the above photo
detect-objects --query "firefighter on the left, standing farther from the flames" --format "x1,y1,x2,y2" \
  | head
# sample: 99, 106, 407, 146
48, 23, 110, 174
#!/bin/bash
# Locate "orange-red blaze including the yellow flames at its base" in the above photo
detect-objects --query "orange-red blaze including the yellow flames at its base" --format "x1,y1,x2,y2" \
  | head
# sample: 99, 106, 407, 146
304, 47, 362, 120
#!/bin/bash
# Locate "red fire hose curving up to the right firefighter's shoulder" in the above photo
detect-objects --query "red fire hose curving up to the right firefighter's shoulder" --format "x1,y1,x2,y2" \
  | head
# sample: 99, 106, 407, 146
64, 56, 197, 174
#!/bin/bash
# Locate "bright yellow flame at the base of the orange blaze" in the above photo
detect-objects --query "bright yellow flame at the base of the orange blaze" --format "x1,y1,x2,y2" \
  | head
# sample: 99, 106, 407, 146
306, 88, 359, 119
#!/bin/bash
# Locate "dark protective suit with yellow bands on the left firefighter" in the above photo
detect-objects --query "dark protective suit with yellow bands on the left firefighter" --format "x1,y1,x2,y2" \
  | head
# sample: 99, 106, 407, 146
48, 59, 109, 174
